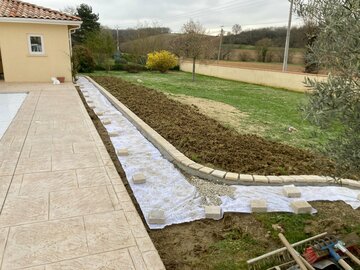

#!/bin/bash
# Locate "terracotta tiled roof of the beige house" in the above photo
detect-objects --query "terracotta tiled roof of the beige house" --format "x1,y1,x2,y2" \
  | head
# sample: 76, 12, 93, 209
0, 0, 81, 22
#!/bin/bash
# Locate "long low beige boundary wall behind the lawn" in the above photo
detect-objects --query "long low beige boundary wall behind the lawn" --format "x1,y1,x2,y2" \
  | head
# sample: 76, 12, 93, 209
180, 61, 327, 92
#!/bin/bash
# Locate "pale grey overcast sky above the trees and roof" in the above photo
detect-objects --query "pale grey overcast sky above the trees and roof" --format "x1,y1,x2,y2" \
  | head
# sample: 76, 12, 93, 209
30, 0, 301, 34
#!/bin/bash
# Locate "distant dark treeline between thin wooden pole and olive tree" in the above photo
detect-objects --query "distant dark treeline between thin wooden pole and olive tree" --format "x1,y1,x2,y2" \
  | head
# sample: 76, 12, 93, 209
224, 26, 307, 48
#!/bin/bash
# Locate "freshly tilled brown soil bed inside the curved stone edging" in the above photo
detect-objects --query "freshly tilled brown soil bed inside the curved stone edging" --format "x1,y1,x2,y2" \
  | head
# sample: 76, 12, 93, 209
93, 76, 334, 175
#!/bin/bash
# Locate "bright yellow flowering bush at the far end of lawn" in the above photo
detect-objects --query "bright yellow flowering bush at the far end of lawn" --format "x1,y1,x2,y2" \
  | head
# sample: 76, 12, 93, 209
146, 51, 178, 73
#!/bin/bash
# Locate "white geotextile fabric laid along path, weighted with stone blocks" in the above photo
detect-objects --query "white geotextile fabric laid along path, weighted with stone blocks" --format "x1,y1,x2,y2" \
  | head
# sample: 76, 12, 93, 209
78, 77, 360, 229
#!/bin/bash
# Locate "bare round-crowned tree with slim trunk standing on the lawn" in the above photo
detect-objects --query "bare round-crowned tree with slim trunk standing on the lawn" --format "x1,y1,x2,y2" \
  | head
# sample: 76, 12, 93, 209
172, 20, 209, 81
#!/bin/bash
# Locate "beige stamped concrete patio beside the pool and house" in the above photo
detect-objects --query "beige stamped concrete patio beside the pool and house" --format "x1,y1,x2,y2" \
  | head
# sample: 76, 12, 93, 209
0, 83, 165, 270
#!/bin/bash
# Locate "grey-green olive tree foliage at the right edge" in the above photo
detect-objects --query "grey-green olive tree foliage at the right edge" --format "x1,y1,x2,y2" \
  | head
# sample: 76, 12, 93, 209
295, 0, 360, 177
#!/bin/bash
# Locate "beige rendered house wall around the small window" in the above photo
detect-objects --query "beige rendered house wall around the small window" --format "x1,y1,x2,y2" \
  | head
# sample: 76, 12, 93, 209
0, 22, 72, 82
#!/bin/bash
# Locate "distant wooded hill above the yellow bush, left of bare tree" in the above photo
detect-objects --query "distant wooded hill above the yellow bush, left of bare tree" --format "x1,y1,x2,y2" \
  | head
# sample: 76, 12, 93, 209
112, 27, 171, 43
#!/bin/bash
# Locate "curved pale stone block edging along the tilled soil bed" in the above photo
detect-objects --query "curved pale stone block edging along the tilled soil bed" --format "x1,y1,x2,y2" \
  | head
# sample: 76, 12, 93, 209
85, 76, 360, 188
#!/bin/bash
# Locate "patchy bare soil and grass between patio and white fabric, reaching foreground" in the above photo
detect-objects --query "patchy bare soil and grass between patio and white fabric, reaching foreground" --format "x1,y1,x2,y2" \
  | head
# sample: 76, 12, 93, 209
79, 86, 360, 270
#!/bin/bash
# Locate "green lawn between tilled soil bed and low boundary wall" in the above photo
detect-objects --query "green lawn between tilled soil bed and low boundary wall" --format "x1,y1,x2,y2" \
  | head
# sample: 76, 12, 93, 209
94, 71, 336, 150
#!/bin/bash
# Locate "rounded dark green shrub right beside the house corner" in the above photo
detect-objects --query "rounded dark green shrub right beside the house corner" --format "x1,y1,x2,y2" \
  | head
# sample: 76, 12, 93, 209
72, 45, 95, 73
